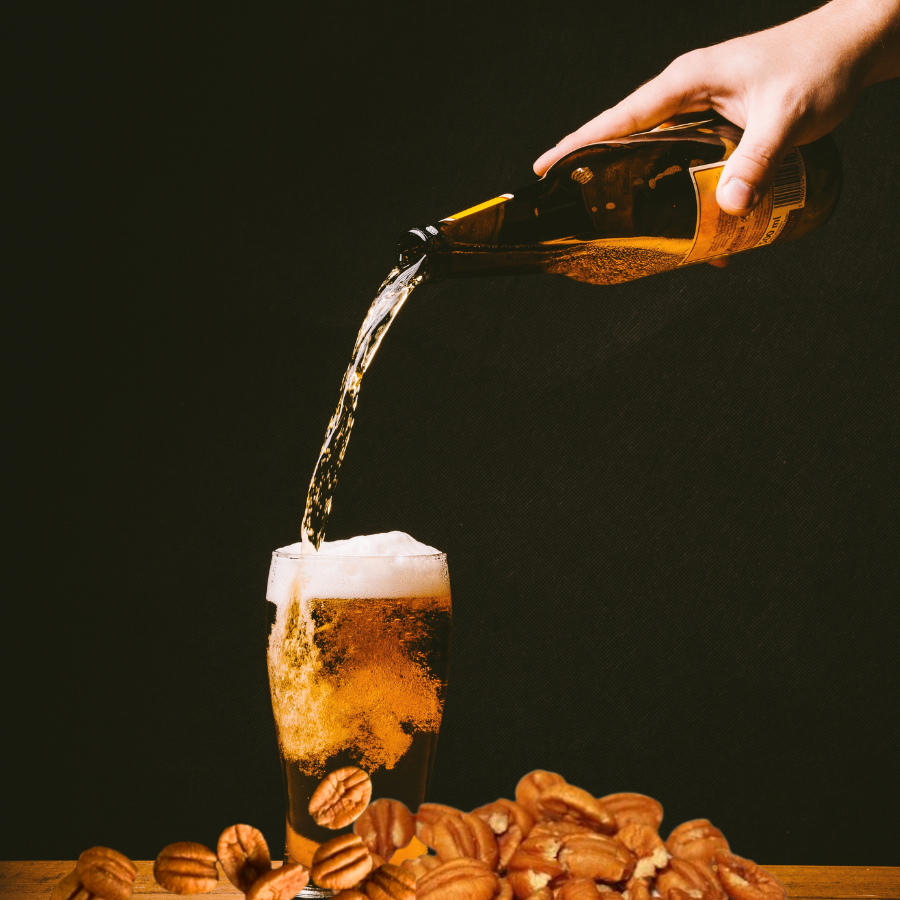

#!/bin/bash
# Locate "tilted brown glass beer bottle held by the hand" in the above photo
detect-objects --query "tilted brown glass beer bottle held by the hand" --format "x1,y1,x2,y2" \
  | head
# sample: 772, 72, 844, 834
397, 116, 841, 284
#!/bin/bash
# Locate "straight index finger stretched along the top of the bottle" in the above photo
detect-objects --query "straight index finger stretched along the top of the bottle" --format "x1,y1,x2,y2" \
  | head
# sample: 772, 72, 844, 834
534, 57, 711, 175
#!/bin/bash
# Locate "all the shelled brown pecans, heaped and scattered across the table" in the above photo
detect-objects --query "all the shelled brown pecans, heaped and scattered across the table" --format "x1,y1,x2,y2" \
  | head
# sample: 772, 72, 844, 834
51, 766, 787, 900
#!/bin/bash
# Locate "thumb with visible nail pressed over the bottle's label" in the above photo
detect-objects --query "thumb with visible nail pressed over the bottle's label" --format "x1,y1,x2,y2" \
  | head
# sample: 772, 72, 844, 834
716, 117, 792, 216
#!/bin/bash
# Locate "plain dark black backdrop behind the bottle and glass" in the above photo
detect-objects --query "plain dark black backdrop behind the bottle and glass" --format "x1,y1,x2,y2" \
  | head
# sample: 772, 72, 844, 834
8, 0, 900, 865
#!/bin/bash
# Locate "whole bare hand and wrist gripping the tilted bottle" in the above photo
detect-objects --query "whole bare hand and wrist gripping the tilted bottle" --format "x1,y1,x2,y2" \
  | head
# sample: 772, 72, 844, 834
534, 0, 900, 217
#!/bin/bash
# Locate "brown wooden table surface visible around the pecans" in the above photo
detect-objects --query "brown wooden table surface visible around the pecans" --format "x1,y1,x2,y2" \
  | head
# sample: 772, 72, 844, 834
0, 860, 900, 900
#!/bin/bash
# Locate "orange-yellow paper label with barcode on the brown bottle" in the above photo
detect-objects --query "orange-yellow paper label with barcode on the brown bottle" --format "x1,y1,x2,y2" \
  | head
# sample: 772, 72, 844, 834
681, 148, 806, 266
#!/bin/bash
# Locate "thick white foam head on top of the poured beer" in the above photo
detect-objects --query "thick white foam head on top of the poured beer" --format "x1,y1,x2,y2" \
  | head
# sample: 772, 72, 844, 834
266, 531, 450, 606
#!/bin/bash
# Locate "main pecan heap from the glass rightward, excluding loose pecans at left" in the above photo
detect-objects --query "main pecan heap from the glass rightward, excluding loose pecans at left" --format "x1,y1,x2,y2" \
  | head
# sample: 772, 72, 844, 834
300, 768, 787, 900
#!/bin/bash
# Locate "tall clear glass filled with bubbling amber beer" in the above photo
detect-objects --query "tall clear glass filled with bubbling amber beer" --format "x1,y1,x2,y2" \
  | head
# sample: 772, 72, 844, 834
266, 550, 450, 897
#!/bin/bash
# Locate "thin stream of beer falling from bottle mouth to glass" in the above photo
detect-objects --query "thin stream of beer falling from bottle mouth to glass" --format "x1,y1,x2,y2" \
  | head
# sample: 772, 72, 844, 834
300, 256, 425, 550
